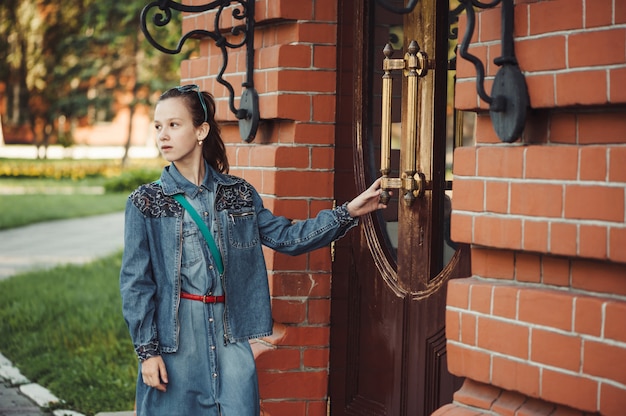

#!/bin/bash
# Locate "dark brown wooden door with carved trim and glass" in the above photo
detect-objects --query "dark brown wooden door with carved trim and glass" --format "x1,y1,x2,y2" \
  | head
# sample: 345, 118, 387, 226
330, 0, 469, 416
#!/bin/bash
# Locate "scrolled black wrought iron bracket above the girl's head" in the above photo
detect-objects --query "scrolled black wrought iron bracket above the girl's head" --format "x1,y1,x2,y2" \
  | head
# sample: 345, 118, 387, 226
140, 0, 260, 142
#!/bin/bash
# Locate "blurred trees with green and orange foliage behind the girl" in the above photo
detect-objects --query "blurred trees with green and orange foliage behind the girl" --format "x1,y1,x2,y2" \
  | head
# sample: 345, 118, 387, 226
0, 0, 191, 161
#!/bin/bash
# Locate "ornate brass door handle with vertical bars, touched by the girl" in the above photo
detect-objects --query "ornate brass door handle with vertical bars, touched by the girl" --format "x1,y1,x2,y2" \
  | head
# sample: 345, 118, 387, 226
380, 40, 432, 206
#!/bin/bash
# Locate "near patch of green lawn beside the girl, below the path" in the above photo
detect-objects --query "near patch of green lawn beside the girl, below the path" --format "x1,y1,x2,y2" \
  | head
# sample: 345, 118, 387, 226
0, 253, 137, 415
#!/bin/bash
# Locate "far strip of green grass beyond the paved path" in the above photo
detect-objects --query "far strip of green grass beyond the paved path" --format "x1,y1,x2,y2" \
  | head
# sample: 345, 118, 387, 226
0, 193, 128, 230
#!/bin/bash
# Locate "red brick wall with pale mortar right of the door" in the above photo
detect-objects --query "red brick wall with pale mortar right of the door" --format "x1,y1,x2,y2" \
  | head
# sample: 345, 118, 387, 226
438, 0, 626, 415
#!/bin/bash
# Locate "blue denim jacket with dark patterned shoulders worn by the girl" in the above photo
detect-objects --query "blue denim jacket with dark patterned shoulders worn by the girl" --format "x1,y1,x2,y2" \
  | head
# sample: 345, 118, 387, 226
120, 165, 358, 360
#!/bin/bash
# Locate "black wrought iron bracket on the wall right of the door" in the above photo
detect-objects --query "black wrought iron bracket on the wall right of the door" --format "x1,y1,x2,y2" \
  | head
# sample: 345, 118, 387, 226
459, 0, 529, 143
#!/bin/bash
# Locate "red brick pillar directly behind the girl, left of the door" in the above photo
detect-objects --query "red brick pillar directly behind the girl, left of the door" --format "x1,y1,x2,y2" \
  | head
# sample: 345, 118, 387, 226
181, 0, 336, 416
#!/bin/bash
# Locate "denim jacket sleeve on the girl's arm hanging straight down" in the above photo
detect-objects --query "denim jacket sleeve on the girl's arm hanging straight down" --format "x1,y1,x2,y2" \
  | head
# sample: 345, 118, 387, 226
120, 199, 159, 361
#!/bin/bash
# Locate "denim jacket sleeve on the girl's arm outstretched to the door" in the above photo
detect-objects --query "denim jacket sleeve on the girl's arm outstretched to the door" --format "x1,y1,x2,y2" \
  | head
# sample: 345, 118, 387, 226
254, 188, 359, 255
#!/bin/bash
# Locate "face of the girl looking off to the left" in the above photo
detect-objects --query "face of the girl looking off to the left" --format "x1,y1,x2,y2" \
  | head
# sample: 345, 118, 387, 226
154, 97, 208, 163
